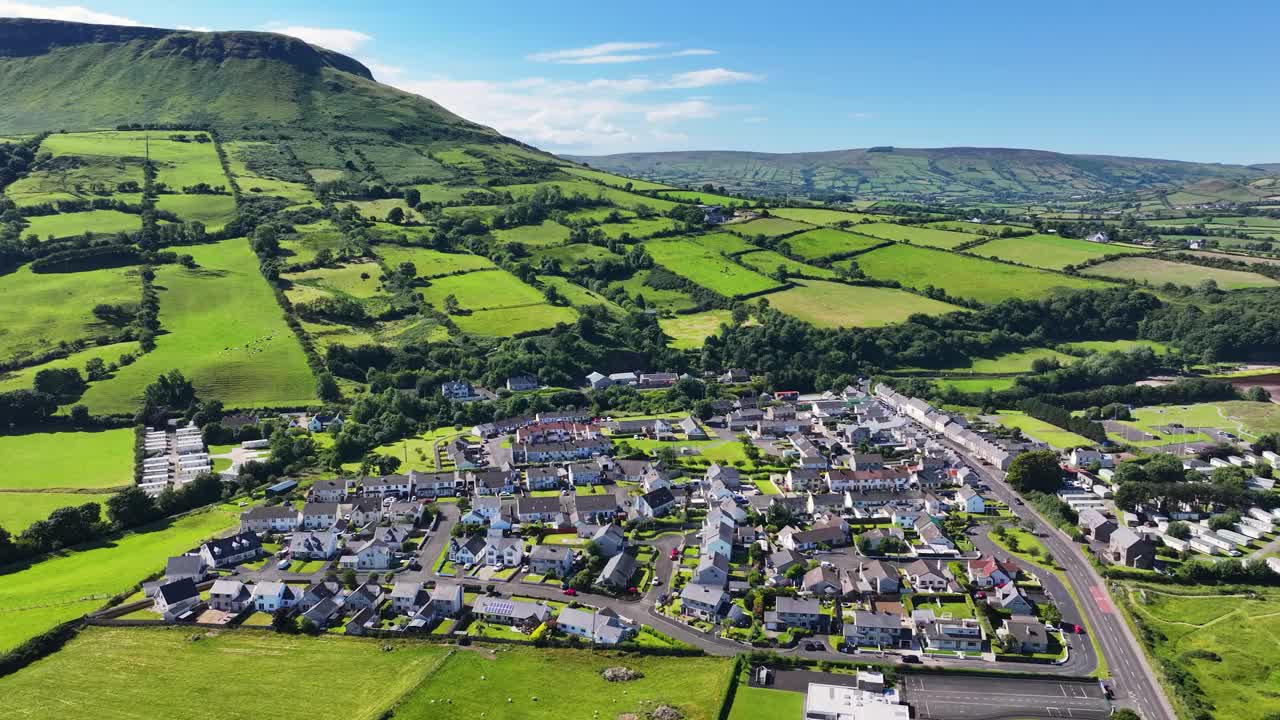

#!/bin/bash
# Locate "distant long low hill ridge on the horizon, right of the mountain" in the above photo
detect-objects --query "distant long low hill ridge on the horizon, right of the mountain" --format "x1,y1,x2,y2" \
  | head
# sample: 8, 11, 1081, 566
568, 147, 1263, 201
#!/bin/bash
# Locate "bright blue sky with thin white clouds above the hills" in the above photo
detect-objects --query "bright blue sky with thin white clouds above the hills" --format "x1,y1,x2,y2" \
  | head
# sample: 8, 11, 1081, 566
0, 0, 1280, 163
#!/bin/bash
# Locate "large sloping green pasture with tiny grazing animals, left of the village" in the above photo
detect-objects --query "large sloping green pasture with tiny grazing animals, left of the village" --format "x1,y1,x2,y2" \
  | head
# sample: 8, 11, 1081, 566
82, 238, 315, 413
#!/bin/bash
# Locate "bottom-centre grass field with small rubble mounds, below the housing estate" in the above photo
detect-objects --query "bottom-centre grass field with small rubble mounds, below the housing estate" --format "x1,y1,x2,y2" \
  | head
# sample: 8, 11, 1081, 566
394, 647, 731, 720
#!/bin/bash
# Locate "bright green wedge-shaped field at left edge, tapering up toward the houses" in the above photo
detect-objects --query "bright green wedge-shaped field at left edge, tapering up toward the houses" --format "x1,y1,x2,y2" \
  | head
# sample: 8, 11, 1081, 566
0, 505, 241, 650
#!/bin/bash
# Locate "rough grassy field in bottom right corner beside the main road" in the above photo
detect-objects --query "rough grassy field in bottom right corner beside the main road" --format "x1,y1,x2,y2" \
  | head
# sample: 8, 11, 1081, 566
1121, 583, 1280, 720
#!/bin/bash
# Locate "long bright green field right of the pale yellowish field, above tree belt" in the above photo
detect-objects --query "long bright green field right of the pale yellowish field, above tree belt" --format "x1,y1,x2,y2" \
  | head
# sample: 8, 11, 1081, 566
855, 243, 1107, 302
